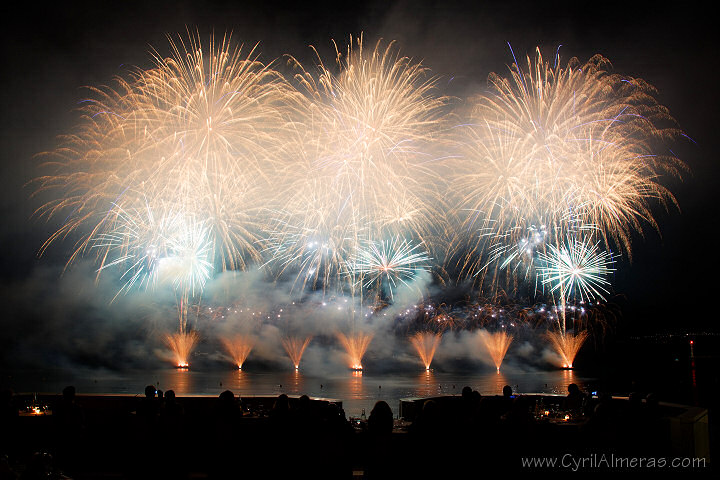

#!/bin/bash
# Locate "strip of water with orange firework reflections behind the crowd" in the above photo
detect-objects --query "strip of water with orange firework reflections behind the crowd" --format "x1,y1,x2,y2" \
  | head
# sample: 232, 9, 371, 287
9, 368, 592, 416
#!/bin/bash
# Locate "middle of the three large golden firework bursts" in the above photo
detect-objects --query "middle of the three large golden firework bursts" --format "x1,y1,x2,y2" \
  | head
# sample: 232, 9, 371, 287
271, 39, 447, 291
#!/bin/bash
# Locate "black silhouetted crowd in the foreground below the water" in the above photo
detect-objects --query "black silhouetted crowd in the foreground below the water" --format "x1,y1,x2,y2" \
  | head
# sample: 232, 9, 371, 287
0, 384, 688, 480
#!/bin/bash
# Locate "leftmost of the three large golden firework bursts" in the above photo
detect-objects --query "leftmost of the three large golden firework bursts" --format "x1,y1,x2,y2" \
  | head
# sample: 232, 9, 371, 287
31, 31, 300, 269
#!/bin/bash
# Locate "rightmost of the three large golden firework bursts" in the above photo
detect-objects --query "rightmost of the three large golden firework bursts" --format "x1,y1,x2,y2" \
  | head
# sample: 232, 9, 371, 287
453, 49, 685, 286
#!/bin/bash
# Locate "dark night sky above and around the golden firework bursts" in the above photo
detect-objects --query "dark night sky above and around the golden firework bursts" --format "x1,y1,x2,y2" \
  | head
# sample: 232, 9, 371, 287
0, 0, 720, 372
